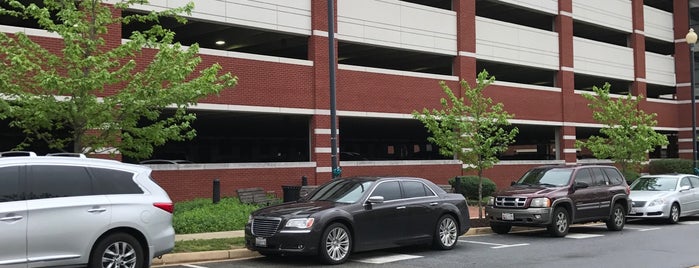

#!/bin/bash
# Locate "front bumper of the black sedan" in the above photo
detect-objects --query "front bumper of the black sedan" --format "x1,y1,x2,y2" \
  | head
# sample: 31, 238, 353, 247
245, 228, 320, 255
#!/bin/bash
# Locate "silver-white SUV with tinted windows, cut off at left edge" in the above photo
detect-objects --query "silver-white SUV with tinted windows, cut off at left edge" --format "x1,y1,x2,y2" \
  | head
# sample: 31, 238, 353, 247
0, 153, 175, 268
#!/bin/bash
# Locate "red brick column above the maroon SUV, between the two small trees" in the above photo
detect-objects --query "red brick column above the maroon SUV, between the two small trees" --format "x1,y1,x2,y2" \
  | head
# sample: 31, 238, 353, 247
555, 0, 577, 164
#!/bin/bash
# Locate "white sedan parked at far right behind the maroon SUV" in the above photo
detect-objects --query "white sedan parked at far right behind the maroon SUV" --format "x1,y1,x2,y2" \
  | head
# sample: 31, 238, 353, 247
628, 174, 699, 223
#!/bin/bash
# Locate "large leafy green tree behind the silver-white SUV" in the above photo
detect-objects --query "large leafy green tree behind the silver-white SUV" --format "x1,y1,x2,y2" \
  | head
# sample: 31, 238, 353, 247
0, 0, 237, 158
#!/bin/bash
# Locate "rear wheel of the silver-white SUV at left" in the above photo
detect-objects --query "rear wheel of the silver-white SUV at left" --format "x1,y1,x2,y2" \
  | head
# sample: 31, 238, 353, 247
88, 233, 146, 268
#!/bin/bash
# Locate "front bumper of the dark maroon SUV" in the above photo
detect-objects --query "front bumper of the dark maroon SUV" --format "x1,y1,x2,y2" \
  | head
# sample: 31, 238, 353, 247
485, 206, 551, 226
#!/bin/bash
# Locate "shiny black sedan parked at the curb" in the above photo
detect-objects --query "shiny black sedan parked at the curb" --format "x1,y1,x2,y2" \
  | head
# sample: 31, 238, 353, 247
245, 177, 470, 264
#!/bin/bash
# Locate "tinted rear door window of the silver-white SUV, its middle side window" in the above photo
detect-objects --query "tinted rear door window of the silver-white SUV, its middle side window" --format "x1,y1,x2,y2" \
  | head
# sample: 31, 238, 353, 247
27, 166, 92, 199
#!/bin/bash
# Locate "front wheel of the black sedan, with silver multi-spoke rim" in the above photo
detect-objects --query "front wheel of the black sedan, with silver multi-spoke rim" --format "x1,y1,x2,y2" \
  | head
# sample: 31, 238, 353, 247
318, 222, 352, 264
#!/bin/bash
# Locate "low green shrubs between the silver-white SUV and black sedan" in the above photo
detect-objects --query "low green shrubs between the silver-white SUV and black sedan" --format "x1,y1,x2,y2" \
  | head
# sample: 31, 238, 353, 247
172, 197, 259, 234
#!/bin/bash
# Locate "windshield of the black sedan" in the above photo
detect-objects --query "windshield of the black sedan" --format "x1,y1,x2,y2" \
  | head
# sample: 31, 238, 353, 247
308, 179, 374, 203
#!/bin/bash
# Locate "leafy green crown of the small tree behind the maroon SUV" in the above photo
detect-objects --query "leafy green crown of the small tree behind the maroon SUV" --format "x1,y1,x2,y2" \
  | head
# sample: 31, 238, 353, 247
575, 83, 668, 171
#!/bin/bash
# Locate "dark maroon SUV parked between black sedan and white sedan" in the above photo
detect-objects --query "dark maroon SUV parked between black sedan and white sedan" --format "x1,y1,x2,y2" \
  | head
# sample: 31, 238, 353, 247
486, 165, 631, 237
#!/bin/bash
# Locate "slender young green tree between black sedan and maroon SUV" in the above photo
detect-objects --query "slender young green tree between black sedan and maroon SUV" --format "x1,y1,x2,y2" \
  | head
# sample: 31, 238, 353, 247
413, 70, 519, 218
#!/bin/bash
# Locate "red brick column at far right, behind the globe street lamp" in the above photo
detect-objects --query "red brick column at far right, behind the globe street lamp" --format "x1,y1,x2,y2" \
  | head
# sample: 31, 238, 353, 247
672, 0, 699, 159
